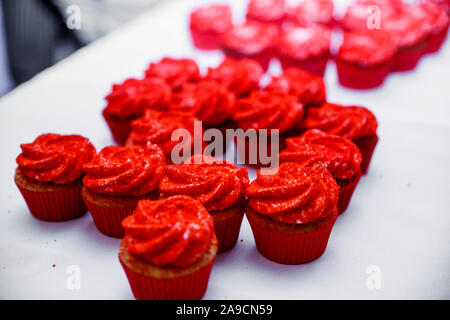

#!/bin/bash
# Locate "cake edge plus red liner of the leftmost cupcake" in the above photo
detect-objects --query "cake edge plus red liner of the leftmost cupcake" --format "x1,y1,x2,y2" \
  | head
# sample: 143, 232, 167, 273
14, 168, 87, 221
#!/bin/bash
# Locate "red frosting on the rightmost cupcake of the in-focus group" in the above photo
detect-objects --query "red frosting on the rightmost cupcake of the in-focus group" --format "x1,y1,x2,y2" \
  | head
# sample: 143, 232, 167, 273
303, 103, 378, 140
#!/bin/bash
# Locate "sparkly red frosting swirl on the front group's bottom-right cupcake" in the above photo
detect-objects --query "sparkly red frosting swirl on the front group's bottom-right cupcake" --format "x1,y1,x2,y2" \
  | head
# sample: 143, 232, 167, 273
246, 162, 339, 225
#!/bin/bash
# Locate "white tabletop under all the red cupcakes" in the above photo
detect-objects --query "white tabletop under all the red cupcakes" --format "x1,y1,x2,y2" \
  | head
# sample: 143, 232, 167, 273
0, 0, 450, 299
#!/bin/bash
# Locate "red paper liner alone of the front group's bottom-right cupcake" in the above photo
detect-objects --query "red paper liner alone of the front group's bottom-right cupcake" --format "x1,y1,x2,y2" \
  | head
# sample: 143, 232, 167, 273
246, 208, 336, 264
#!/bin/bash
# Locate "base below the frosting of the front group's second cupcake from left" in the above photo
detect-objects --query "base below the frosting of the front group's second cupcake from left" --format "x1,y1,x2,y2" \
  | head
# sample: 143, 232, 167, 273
81, 187, 158, 238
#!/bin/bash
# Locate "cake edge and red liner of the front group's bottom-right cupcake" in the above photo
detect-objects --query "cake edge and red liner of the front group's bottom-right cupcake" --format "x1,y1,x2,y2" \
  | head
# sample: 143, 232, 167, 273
246, 207, 337, 264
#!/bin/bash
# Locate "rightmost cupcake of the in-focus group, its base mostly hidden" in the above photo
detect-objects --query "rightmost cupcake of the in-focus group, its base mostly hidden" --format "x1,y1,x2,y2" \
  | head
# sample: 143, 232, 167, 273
303, 103, 378, 174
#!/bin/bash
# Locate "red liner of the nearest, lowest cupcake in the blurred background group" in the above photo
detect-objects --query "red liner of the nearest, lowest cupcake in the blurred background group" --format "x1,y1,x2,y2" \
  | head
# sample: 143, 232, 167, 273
336, 59, 393, 90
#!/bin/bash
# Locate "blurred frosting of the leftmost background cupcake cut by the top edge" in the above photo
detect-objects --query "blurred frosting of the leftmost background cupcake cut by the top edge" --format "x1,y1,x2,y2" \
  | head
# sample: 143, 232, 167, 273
247, 0, 286, 22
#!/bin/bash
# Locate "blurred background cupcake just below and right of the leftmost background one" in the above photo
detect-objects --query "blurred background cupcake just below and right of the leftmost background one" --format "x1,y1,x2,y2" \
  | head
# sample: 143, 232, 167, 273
222, 21, 278, 71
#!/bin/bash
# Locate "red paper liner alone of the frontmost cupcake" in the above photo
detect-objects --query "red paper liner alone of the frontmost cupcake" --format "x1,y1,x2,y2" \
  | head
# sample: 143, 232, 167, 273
119, 257, 215, 300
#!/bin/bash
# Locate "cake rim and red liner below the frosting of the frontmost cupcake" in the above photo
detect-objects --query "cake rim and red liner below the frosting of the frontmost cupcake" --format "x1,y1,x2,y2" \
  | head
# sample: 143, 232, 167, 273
119, 237, 218, 300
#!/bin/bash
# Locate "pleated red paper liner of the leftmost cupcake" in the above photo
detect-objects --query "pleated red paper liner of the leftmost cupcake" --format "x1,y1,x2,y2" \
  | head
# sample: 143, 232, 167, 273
17, 181, 87, 221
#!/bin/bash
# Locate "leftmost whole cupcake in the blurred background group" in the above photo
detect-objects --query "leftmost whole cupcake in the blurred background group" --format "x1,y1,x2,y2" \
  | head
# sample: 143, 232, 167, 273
189, 4, 232, 50
